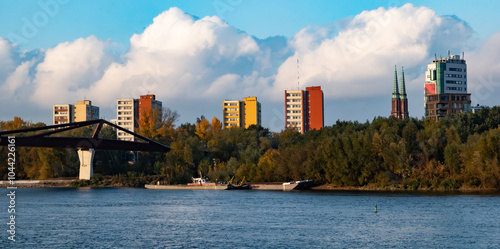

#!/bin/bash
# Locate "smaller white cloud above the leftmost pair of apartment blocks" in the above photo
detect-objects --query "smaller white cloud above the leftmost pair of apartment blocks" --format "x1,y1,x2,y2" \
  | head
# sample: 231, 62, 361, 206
31, 36, 111, 106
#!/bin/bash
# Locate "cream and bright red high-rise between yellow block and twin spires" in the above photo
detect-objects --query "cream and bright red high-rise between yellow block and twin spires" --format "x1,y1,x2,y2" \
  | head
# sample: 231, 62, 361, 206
285, 86, 324, 133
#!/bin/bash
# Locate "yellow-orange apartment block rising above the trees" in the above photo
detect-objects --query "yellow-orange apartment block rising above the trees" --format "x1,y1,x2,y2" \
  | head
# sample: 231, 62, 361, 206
222, 97, 262, 128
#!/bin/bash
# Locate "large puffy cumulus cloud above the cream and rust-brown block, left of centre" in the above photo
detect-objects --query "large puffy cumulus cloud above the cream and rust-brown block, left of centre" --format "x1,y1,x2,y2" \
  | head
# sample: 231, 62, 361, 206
82, 8, 284, 110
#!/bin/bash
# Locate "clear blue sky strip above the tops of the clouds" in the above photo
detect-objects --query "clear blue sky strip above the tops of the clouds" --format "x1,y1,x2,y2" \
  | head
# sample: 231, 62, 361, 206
0, 0, 500, 50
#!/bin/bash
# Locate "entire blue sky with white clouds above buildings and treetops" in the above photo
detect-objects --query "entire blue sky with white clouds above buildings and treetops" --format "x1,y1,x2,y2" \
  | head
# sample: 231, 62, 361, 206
0, 0, 500, 131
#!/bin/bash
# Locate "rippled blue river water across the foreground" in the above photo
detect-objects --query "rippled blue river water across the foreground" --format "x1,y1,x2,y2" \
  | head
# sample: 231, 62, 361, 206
0, 188, 500, 248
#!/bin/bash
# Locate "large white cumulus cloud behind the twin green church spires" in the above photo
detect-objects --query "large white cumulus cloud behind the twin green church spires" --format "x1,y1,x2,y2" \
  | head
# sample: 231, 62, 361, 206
273, 4, 473, 99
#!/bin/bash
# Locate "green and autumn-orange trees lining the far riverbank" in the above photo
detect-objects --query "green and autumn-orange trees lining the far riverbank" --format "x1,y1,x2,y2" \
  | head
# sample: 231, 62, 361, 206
0, 107, 500, 192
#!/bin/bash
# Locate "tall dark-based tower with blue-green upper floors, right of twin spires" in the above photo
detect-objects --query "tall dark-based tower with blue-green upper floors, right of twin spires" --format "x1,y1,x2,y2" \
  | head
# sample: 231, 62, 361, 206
425, 53, 471, 121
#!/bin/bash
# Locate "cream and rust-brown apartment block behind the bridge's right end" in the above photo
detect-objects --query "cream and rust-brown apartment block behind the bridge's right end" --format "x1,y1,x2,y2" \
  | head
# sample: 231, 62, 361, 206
116, 94, 162, 141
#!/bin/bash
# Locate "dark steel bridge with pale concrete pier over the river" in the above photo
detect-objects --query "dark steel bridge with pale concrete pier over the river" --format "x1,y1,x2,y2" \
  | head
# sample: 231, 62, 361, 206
0, 119, 170, 180
